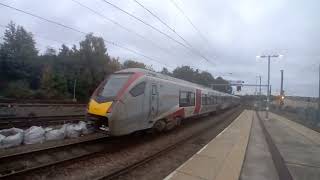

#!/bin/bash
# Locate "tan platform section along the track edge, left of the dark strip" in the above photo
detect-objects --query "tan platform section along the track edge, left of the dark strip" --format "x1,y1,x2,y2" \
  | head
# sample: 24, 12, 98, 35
166, 110, 254, 180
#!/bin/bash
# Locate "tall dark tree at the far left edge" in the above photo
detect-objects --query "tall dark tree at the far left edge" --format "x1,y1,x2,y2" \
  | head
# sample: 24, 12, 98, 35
0, 22, 40, 91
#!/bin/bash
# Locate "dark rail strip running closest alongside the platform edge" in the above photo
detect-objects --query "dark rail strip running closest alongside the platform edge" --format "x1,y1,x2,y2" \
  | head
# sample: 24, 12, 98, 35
95, 109, 242, 180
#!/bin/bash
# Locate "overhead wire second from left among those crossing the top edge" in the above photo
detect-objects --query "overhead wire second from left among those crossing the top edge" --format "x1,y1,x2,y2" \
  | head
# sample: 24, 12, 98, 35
102, 0, 214, 62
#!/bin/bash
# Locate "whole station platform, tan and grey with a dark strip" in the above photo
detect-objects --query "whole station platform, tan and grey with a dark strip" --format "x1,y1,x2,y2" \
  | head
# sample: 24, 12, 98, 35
165, 110, 320, 180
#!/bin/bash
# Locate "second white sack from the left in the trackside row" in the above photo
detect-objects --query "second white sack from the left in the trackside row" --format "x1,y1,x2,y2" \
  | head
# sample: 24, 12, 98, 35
23, 126, 45, 144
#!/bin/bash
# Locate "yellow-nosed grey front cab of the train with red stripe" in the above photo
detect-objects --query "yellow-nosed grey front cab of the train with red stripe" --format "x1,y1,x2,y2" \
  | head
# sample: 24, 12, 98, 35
87, 73, 159, 136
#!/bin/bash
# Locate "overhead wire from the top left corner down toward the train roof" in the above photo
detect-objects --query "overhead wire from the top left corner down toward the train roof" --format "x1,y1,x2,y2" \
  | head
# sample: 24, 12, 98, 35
0, 2, 174, 67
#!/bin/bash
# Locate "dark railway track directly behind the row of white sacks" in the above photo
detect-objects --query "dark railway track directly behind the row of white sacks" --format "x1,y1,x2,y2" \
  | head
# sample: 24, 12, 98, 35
0, 115, 85, 129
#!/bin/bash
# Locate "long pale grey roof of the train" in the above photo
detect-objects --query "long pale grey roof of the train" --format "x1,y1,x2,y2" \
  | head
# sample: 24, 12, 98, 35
116, 68, 238, 97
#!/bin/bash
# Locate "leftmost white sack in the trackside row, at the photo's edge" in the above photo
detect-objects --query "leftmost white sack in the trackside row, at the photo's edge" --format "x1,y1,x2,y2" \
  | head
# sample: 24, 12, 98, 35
0, 128, 23, 148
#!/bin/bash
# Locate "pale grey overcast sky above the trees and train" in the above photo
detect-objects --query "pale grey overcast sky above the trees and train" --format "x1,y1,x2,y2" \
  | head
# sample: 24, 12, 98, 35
0, 0, 320, 96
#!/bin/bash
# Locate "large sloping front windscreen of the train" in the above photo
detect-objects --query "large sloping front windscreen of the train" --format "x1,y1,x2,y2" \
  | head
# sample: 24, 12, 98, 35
98, 74, 131, 97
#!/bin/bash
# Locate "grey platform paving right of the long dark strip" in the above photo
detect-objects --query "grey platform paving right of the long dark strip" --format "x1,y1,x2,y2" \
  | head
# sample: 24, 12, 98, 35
264, 113, 320, 180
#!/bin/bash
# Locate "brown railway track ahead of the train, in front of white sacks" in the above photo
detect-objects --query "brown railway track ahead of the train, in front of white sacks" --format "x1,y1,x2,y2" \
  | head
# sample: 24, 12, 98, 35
0, 133, 109, 179
